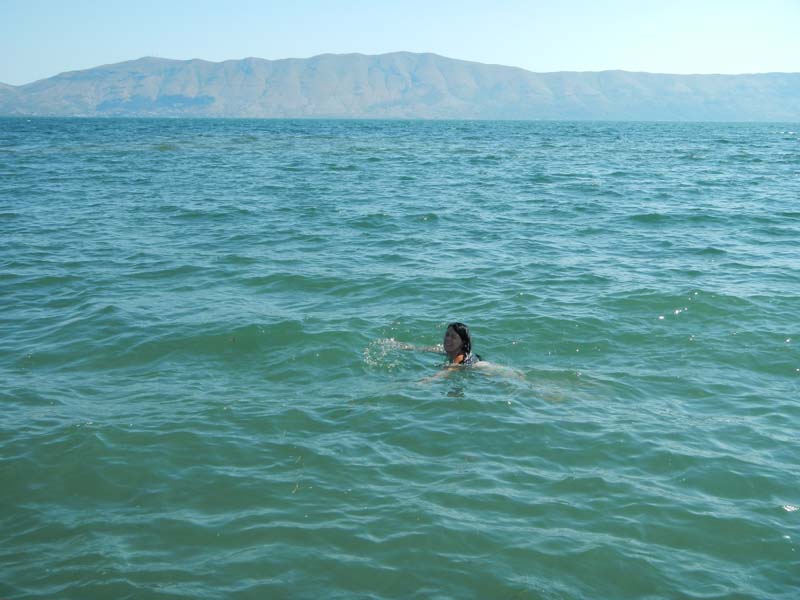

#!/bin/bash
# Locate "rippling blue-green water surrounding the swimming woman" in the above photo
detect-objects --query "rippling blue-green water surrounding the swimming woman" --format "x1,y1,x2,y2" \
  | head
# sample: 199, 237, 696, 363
0, 118, 800, 599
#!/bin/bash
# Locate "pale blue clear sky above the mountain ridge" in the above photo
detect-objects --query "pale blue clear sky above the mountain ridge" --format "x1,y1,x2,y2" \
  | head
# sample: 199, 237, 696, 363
0, 0, 800, 85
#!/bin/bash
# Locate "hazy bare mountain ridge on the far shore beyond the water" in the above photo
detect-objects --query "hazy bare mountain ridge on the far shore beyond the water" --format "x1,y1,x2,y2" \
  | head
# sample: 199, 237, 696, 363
0, 52, 800, 121
